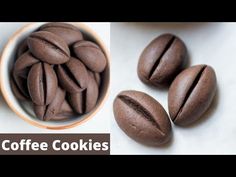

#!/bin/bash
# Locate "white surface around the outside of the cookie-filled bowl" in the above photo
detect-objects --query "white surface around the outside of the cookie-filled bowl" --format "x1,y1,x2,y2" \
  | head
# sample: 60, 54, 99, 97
0, 23, 110, 133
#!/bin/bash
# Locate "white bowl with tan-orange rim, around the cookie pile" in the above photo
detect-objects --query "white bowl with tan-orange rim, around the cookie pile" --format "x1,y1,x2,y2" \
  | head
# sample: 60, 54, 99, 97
0, 23, 110, 129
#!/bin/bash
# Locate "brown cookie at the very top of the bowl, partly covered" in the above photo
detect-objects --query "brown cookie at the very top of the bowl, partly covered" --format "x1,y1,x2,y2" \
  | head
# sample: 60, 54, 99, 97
40, 23, 83, 45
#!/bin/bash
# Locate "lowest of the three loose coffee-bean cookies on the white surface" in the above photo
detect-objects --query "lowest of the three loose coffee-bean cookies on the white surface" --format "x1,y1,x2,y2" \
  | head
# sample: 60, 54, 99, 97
113, 90, 172, 146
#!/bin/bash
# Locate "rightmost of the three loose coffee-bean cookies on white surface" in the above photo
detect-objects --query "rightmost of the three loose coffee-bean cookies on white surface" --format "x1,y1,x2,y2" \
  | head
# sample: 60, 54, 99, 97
168, 65, 217, 126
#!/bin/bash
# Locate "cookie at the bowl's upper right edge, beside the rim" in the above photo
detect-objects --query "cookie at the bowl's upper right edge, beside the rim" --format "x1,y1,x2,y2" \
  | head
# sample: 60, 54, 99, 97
73, 41, 107, 73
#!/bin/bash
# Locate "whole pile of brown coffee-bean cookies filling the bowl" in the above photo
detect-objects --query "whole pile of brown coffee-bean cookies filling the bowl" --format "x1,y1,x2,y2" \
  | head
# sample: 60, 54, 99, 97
11, 23, 107, 121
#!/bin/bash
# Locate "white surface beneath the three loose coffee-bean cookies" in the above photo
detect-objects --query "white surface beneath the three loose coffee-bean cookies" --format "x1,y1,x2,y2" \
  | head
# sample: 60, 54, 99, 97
108, 23, 236, 154
